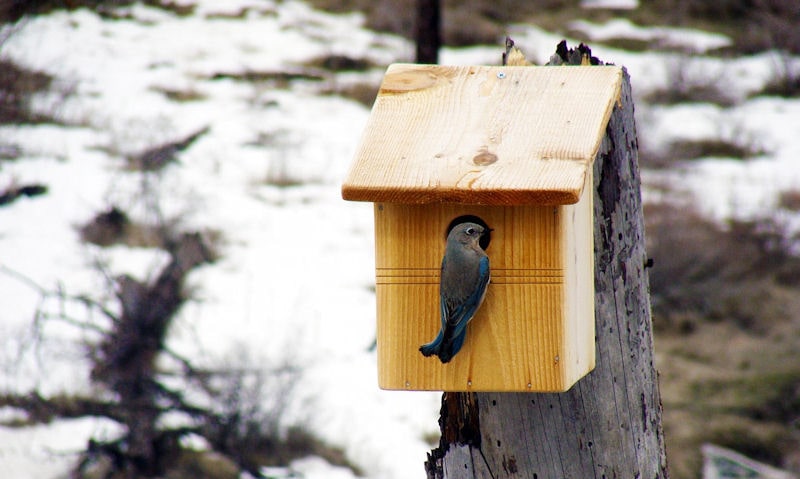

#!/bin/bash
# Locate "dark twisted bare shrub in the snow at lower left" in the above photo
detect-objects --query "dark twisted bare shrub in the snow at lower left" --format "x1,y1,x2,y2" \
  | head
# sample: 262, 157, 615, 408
0, 225, 350, 479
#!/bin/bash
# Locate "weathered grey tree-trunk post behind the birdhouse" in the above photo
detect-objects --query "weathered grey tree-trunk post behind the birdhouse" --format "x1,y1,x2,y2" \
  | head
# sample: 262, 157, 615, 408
426, 73, 668, 479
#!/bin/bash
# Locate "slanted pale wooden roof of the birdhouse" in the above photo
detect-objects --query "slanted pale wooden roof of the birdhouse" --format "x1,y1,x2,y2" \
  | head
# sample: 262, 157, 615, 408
342, 64, 622, 205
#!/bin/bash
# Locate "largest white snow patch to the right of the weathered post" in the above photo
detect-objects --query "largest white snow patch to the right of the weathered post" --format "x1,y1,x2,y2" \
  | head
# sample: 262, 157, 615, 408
647, 97, 800, 219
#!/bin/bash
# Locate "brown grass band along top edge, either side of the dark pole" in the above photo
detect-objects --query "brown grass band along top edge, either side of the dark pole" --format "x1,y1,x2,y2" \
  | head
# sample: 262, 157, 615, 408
304, 0, 800, 54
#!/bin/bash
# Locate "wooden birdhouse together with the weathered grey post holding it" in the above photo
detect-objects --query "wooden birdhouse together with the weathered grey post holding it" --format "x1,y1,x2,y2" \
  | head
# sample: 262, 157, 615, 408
342, 42, 667, 479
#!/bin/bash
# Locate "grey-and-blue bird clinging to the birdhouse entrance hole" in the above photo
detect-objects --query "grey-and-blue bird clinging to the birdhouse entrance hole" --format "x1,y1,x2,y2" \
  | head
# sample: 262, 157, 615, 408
419, 223, 490, 363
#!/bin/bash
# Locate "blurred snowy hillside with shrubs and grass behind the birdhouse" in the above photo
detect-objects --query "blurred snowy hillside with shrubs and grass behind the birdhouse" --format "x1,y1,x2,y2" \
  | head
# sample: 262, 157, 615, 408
0, 0, 800, 479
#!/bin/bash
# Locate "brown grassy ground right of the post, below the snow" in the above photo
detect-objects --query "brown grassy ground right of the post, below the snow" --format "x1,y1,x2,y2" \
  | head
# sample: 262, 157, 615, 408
645, 205, 800, 478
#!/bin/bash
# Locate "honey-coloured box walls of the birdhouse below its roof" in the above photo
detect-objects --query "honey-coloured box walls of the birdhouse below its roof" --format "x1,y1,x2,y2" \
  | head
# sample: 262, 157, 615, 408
375, 174, 594, 391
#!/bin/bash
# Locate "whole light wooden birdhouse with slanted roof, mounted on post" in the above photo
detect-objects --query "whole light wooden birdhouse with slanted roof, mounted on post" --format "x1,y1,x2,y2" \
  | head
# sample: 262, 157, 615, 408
342, 64, 622, 391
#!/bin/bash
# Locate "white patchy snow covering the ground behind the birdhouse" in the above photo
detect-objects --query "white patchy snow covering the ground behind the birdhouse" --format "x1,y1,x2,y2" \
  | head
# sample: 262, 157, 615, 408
0, 0, 800, 479
